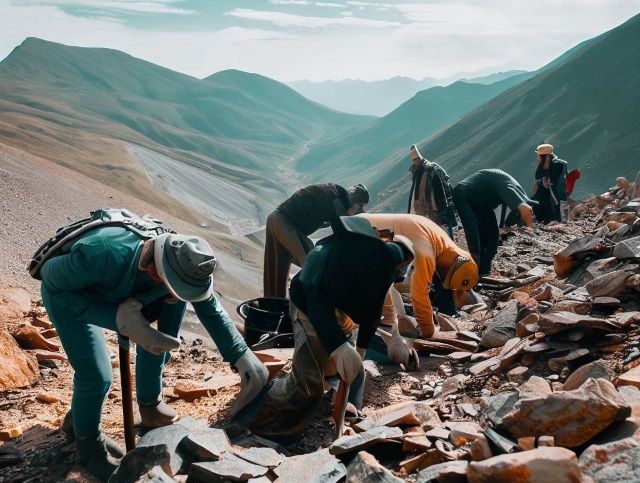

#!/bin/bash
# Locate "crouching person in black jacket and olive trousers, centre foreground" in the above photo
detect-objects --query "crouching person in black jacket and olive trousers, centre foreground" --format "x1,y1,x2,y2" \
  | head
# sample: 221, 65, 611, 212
243, 216, 413, 439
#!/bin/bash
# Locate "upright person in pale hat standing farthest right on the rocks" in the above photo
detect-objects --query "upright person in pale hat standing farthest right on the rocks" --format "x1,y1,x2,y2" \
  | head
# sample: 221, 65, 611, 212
532, 144, 569, 224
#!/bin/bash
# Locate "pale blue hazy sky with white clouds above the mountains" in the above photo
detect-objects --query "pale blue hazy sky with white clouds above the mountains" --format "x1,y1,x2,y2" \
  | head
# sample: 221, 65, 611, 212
0, 0, 640, 81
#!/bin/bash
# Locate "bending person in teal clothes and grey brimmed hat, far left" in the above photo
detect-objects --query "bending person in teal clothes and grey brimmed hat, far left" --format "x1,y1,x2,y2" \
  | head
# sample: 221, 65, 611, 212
41, 227, 268, 480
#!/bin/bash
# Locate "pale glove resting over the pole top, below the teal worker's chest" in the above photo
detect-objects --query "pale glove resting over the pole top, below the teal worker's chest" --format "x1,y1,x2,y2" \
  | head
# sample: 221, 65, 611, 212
116, 299, 180, 356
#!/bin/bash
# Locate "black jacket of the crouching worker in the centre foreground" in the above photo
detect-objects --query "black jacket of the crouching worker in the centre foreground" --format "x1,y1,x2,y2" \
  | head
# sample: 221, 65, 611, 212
289, 233, 402, 354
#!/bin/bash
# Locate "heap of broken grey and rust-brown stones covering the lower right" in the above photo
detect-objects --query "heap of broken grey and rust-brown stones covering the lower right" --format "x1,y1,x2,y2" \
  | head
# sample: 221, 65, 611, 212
0, 174, 640, 483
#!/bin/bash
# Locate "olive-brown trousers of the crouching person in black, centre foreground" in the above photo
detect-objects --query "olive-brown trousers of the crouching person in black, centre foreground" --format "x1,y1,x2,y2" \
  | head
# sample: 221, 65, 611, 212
249, 304, 336, 438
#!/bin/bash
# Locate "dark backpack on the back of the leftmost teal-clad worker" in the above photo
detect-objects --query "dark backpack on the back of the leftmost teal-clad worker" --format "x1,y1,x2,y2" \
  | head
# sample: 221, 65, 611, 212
27, 208, 176, 280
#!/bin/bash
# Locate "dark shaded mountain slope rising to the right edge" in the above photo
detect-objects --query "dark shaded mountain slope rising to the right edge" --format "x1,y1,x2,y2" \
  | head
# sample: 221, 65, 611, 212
372, 26, 640, 210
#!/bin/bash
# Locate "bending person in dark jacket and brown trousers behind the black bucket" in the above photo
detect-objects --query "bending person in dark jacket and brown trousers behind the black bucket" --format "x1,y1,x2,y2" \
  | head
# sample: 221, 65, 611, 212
263, 183, 369, 298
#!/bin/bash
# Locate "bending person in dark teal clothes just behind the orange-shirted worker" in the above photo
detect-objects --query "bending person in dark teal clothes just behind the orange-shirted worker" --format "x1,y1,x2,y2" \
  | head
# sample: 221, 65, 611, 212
453, 169, 535, 276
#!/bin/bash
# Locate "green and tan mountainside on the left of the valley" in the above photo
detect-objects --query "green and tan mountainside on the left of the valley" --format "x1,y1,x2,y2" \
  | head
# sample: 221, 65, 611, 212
0, 38, 371, 233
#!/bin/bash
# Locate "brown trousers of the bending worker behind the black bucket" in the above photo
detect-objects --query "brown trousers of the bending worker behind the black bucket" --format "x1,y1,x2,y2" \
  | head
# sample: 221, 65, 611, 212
263, 211, 313, 298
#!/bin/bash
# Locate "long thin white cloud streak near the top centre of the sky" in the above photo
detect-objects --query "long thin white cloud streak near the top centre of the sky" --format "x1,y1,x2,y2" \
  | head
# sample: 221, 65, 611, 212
225, 8, 402, 28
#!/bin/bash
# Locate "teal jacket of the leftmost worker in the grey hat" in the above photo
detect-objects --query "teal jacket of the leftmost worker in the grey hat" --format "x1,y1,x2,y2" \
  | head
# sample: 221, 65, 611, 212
41, 227, 247, 364
